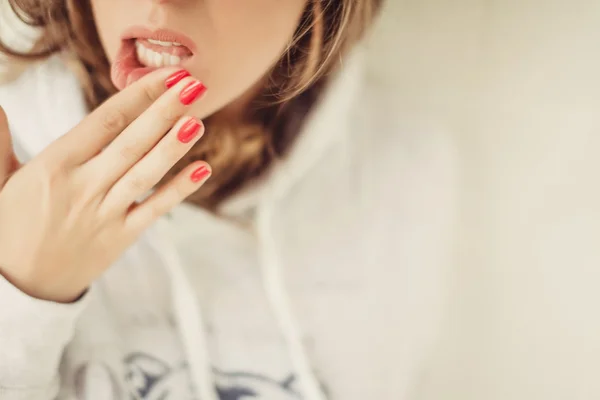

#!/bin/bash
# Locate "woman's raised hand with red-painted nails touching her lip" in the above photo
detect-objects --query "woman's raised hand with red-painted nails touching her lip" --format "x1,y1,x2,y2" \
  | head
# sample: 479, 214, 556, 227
0, 69, 211, 302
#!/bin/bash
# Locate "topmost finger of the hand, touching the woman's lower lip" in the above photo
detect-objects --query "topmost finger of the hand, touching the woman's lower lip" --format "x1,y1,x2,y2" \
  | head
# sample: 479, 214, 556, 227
47, 68, 183, 165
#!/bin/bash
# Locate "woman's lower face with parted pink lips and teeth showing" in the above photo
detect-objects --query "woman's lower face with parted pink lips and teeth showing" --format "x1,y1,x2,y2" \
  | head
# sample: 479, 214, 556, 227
91, 0, 308, 118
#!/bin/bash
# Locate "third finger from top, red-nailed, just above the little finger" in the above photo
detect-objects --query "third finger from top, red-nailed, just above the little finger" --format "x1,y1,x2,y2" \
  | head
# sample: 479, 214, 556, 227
102, 117, 204, 212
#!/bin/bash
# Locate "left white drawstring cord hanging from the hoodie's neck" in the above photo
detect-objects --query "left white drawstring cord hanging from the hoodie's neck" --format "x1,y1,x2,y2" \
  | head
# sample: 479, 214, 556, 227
153, 220, 219, 400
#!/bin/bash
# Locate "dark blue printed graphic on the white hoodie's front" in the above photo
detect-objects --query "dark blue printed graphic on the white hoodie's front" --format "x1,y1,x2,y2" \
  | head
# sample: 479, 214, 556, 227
75, 353, 301, 400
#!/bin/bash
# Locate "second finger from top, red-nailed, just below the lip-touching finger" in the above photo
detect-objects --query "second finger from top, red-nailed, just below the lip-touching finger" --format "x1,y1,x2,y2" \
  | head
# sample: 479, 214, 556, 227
88, 77, 206, 187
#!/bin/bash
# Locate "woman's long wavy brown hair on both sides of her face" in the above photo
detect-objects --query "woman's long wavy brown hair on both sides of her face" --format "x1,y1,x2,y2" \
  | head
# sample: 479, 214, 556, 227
0, 0, 383, 209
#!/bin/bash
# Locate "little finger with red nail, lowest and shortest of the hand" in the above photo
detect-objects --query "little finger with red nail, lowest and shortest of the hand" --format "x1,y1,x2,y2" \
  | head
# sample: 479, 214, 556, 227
124, 161, 212, 234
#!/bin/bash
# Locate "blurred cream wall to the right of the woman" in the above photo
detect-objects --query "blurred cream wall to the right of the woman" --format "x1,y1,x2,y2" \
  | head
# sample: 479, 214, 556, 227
374, 0, 600, 400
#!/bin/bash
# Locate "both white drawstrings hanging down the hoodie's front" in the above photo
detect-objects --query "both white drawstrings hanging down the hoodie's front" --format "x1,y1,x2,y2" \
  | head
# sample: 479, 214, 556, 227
148, 212, 326, 400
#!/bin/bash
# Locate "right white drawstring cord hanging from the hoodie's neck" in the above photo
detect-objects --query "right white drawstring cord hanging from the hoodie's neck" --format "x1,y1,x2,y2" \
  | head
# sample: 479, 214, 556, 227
256, 203, 326, 400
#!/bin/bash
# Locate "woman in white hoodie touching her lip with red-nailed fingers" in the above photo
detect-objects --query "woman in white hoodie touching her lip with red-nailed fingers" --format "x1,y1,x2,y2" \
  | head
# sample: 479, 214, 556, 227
0, 0, 453, 399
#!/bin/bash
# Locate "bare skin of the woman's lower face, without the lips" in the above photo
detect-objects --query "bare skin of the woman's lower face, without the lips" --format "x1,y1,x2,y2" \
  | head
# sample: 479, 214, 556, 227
91, 0, 308, 119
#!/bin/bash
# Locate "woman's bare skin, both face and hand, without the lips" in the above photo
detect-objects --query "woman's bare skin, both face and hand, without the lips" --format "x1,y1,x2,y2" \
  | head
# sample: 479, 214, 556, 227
0, 0, 307, 303
